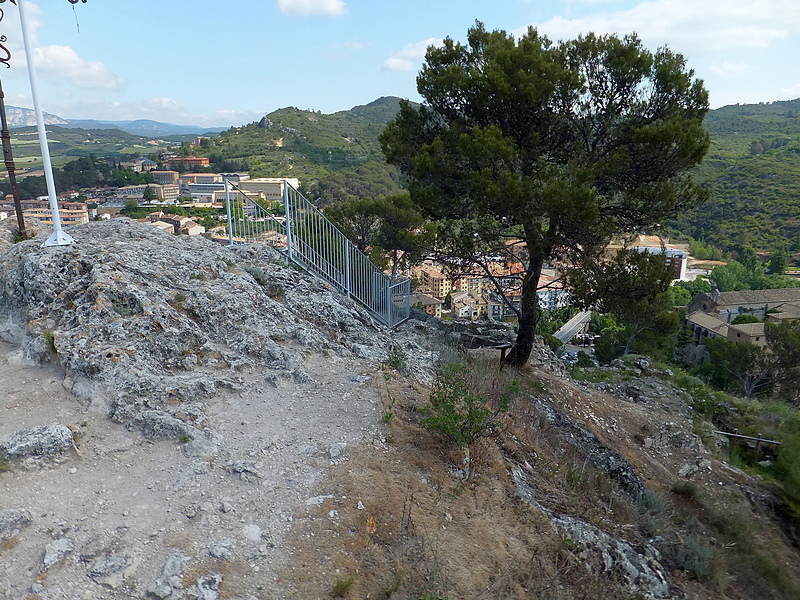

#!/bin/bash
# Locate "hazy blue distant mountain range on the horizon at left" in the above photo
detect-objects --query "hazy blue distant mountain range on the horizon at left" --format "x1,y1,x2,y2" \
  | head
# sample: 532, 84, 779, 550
6, 106, 227, 138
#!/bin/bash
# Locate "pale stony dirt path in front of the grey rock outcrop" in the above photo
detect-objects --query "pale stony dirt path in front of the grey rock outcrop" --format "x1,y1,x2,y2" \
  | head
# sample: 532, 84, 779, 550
0, 343, 382, 600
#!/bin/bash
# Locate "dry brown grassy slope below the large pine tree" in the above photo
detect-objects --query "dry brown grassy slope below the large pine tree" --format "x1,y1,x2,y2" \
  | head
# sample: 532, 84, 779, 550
281, 357, 800, 600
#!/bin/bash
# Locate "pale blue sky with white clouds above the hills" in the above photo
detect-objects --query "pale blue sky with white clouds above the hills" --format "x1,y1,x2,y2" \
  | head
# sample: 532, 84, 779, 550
0, 0, 800, 127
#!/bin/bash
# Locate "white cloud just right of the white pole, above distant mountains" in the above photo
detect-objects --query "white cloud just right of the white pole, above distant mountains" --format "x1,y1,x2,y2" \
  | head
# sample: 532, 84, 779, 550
33, 46, 125, 90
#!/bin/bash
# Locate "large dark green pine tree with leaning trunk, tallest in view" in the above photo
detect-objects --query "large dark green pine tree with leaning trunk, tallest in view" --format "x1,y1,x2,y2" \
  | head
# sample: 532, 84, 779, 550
381, 23, 708, 365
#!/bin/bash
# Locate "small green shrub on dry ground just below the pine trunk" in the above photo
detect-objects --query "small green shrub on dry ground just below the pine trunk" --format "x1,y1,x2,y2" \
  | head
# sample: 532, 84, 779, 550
421, 363, 520, 448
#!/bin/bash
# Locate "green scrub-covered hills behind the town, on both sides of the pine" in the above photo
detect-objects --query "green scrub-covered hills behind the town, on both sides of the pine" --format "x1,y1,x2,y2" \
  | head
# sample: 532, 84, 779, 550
6, 97, 800, 254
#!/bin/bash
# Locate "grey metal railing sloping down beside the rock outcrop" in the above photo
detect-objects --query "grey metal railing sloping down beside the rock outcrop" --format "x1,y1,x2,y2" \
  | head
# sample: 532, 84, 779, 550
225, 179, 411, 327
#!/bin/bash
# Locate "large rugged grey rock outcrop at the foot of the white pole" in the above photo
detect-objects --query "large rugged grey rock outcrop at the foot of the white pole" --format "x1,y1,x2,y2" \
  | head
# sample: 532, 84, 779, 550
0, 219, 388, 437
